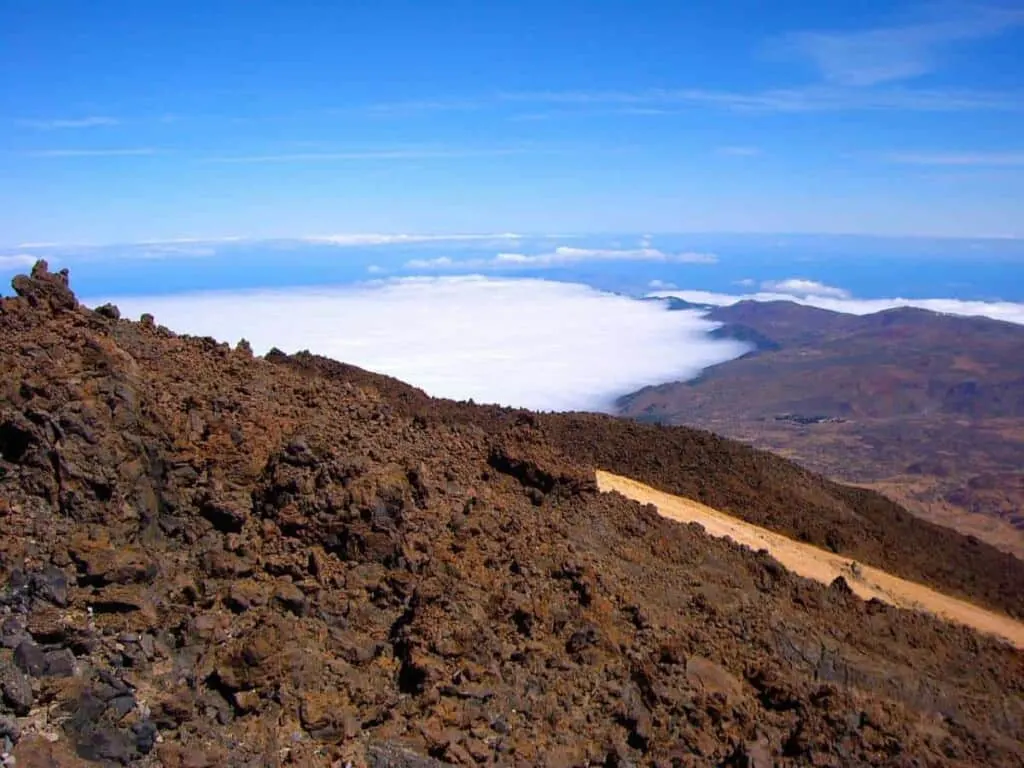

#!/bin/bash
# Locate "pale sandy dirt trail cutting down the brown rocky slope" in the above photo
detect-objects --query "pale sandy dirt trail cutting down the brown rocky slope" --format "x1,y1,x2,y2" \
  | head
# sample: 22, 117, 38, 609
597, 471, 1024, 649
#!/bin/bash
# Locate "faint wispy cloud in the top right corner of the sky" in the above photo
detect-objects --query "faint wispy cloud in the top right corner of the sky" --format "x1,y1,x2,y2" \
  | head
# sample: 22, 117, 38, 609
775, 4, 1024, 87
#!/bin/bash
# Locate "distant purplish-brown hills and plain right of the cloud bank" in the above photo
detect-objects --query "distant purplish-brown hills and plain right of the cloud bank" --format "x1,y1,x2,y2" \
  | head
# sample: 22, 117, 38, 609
621, 301, 1024, 557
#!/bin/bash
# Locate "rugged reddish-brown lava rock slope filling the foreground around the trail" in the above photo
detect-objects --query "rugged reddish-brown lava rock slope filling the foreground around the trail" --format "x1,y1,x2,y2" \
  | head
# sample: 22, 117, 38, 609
0, 265, 1024, 767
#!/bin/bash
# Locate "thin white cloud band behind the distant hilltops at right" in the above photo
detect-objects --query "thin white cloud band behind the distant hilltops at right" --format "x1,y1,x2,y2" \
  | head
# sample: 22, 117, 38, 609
649, 281, 1024, 325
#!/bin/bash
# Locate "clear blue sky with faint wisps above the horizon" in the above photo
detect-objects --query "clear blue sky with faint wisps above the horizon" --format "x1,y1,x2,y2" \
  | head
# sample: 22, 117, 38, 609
0, 0, 1024, 247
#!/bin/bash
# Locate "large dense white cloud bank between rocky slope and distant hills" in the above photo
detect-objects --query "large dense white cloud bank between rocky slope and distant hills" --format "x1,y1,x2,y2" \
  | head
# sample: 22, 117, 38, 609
89, 276, 746, 410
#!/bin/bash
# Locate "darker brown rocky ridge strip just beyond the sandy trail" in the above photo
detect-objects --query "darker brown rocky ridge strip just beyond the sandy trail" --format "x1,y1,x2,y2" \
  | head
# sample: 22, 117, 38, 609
268, 352, 1024, 617
